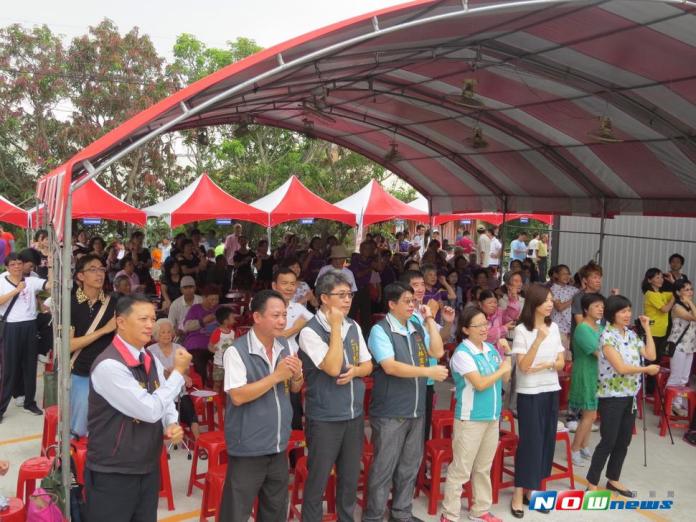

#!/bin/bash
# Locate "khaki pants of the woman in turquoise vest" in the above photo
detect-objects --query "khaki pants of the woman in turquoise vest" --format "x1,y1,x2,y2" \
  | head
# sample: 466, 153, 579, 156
442, 420, 500, 520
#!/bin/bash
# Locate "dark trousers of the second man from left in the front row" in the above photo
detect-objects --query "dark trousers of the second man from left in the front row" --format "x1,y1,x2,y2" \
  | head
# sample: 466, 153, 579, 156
220, 451, 289, 522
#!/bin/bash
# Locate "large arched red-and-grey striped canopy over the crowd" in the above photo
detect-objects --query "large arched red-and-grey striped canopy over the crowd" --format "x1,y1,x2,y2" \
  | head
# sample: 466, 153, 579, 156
38, 0, 696, 238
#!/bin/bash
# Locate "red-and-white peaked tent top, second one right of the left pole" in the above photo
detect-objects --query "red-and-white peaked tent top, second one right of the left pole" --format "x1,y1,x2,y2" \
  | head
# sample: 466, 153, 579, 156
143, 174, 268, 228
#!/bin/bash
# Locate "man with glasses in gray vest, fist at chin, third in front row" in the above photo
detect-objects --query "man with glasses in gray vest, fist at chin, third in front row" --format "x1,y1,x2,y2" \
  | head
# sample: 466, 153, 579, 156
299, 270, 372, 522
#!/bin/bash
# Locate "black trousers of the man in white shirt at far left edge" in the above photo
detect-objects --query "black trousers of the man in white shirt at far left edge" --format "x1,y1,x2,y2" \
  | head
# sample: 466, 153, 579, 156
0, 320, 38, 415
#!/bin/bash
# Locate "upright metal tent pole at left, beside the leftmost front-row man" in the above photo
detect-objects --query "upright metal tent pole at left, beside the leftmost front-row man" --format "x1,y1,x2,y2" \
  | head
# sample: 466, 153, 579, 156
58, 191, 72, 520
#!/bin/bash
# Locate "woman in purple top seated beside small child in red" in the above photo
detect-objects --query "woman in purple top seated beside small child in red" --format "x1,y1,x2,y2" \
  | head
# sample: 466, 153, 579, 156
184, 285, 220, 386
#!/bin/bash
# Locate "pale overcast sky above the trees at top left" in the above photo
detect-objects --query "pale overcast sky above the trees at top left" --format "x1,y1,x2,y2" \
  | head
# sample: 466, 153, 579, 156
0, 0, 403, 58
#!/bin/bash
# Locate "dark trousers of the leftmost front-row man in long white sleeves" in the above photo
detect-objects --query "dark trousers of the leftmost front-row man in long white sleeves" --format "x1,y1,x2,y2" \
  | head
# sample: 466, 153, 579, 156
85, 466, 160, 522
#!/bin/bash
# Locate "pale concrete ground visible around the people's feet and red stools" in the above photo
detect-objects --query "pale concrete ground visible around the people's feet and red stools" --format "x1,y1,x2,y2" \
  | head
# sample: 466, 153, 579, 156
0, 370, 696, 522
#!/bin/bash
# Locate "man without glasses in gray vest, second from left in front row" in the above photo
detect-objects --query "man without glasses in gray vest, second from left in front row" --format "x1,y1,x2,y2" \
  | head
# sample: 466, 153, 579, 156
220, 290, 303, 522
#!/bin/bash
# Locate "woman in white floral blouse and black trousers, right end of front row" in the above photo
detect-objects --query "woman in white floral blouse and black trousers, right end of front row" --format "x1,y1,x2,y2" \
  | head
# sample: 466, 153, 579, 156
587, 295, 660, 498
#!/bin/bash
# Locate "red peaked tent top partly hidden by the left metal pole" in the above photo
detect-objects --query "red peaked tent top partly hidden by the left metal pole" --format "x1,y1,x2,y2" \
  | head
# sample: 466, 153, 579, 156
29, 180, 147, 227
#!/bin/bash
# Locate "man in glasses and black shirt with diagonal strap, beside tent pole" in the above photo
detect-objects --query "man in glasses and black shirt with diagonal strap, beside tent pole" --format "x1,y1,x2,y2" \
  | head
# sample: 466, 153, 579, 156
70, 254, 117, 437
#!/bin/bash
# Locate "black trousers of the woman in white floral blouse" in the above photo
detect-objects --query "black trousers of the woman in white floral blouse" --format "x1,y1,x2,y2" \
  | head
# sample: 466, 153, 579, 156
587, 397, 636, 486
